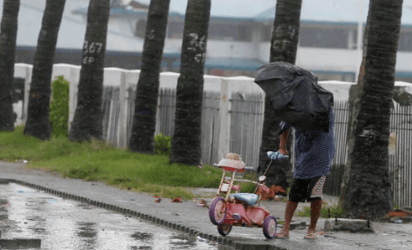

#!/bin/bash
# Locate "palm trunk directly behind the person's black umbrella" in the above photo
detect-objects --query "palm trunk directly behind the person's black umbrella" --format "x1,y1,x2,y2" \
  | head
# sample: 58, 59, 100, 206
258, 0, 302, 188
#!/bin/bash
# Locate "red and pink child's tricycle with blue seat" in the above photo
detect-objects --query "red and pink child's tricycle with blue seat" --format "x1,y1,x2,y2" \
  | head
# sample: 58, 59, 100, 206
209, 153, 277, 239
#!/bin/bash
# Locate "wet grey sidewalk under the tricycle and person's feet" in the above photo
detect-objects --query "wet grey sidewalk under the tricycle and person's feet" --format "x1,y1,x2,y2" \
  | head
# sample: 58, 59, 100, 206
0, 162, 412, 250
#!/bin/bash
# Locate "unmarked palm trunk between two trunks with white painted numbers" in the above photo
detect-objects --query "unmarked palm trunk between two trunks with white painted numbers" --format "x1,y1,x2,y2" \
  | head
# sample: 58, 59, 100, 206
129, 0, 170, 153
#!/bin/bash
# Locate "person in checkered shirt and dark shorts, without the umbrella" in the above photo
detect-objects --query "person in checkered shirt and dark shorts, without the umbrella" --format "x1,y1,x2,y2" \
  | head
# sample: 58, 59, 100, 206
268, 107, 335, 239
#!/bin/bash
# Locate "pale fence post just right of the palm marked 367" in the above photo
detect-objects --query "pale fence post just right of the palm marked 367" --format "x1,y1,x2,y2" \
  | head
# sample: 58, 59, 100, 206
117, 70, 127, 148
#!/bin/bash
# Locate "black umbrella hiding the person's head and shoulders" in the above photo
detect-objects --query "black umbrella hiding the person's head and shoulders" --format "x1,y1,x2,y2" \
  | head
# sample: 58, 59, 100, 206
255, 62, 333, 133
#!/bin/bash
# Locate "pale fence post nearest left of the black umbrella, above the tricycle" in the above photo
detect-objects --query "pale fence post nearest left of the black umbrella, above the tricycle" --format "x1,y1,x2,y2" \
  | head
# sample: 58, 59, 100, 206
218, 78, 231, 159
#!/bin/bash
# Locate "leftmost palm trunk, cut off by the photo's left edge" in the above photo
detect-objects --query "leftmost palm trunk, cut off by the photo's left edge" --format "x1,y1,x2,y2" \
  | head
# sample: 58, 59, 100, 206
0, 0, 20, 131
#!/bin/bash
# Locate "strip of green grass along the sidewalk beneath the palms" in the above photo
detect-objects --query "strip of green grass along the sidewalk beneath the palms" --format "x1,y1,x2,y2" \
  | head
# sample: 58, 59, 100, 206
0, 126, 254, 199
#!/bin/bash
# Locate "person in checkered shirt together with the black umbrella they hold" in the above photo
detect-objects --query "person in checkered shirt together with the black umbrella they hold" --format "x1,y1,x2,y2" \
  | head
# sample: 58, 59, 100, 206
255, 62, 335, 239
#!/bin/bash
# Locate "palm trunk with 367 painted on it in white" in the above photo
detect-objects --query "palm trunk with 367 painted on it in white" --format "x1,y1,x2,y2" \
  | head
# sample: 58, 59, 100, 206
69, 0, 110, 142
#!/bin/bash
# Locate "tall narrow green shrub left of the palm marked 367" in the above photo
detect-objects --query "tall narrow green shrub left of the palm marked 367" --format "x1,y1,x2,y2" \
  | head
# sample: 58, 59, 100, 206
49, 76, 70, 136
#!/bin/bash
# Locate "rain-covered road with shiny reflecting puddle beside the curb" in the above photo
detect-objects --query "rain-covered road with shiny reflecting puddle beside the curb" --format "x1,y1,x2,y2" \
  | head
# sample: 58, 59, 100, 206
0, 183, 225, 250
